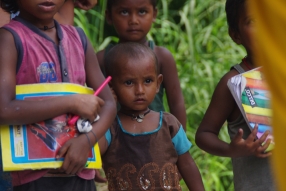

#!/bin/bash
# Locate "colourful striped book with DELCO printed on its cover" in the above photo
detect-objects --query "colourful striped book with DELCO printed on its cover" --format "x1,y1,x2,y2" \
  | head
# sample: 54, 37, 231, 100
227, 67, 274, 151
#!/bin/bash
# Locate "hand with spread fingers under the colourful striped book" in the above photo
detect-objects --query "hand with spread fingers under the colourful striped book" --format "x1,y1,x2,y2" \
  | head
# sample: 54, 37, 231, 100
229, 124, 271, 158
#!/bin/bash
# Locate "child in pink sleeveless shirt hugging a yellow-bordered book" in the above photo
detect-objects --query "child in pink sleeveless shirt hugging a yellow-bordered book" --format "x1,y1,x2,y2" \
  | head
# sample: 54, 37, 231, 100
0, 0, 116, 191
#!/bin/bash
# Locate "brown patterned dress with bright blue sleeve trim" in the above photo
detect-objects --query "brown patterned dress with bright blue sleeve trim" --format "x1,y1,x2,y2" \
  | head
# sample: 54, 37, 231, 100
102, 112, 191, 191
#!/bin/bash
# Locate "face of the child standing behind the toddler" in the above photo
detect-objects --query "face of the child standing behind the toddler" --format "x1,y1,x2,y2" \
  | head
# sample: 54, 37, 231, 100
106, 0, 157, 42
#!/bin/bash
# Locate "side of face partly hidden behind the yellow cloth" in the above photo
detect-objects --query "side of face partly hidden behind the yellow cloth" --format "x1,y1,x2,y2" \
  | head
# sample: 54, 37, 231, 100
230, 3, 256, 56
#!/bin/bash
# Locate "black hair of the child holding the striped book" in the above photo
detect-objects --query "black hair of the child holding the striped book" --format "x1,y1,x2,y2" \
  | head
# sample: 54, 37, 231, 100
225, 0, 245, 31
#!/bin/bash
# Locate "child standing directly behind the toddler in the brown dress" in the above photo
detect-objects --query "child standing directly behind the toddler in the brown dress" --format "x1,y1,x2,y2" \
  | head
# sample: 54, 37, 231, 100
97, 0, 186, 129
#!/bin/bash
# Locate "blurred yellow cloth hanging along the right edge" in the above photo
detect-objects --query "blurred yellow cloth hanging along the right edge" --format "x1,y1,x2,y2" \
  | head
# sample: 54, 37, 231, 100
248, 0, 286, 190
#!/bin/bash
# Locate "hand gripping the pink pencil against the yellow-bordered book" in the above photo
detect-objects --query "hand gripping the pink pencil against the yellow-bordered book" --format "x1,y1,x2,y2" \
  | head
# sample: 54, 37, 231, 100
72, 94, 104, 122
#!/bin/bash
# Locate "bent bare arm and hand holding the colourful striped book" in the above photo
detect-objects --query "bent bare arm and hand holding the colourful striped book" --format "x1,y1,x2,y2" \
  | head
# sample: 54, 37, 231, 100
196, 71, 271, 157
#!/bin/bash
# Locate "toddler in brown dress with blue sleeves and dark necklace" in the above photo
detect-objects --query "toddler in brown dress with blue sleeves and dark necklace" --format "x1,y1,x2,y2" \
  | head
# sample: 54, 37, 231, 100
99, 42, 204, 191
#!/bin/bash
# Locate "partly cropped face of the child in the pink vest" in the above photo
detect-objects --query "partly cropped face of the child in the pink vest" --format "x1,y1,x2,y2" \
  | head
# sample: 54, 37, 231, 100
18, 0, 65, 21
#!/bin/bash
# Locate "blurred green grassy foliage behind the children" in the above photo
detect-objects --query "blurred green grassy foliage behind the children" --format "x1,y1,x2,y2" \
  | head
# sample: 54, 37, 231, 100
75, 0, 245, 191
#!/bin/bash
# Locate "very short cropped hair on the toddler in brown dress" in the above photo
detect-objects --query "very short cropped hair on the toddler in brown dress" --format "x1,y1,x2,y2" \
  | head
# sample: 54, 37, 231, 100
104, 42, 159, 77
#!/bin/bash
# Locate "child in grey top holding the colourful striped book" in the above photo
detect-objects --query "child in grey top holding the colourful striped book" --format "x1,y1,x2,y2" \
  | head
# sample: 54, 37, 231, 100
196, 0, 275, 191
